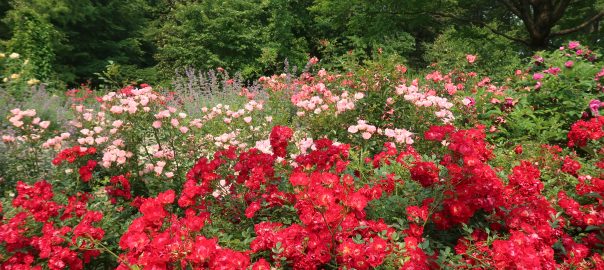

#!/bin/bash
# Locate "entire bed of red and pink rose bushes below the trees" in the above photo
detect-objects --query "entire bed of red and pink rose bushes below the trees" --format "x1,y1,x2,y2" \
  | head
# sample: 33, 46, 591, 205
0, 43, 604, 270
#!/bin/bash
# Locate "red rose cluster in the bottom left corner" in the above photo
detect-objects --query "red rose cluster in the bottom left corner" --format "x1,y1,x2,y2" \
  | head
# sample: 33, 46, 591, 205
0, 181, 105, 270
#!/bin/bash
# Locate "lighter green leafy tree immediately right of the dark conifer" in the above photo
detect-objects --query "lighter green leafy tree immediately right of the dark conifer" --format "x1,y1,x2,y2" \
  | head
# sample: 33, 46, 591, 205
156, 0, 267, 76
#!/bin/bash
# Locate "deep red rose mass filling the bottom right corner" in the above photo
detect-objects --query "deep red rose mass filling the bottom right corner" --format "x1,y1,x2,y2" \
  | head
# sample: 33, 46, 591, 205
416, 127, 604, 269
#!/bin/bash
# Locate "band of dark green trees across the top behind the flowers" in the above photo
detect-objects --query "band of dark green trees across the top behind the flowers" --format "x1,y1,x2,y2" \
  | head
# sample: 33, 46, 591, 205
0, 0, 604, 82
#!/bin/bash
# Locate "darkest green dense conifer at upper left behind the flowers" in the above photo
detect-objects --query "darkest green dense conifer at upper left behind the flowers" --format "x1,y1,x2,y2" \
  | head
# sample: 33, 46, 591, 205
52, 0, 154, 81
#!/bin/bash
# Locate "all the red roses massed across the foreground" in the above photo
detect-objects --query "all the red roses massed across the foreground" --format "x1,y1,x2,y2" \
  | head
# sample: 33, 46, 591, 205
5, 123, 604, 270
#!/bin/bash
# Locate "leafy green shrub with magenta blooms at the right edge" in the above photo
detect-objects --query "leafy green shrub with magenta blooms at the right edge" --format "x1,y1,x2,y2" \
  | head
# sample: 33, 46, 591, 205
501, 42, 604, 143
